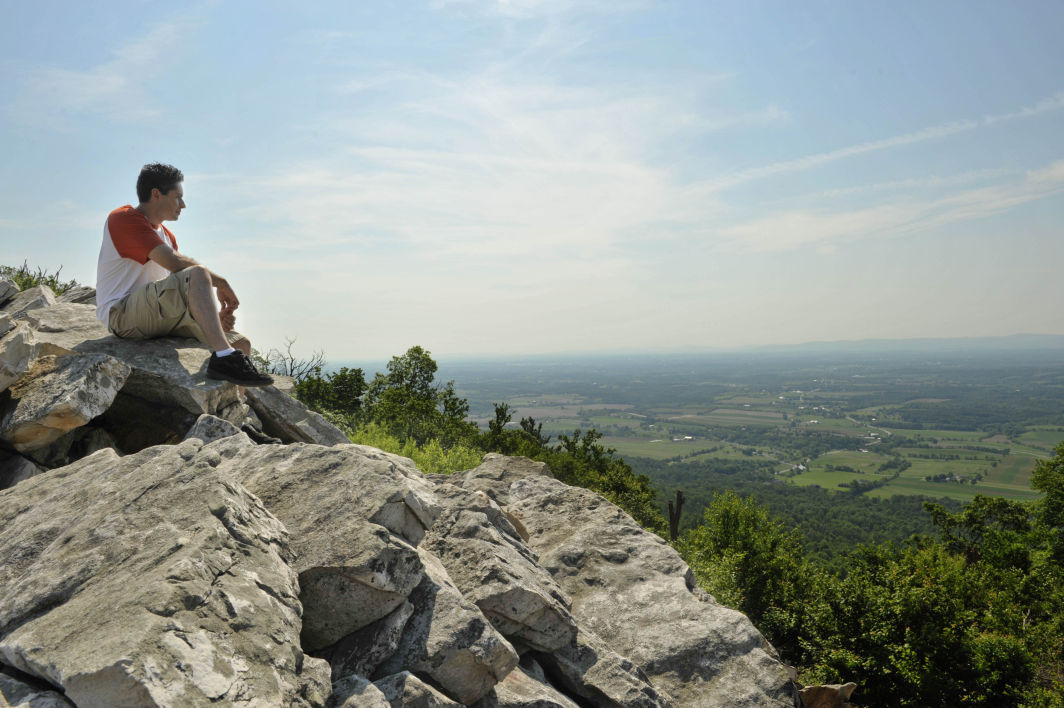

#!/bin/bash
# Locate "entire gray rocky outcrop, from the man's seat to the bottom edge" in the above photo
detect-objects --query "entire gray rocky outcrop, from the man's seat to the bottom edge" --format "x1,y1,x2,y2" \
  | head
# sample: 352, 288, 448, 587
0, 283, 804, 708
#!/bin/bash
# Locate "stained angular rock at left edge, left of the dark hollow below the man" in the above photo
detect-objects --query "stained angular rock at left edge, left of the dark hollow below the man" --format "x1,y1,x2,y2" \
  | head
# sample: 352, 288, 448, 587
0, 355, 130, 452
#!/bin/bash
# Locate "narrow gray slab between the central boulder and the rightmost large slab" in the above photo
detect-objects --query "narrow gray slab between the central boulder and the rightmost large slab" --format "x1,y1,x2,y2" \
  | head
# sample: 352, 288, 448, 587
422, 483, 577, 652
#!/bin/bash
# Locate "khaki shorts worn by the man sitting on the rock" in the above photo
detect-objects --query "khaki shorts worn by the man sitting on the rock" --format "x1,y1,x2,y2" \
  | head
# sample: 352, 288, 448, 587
107, 269, 244, 344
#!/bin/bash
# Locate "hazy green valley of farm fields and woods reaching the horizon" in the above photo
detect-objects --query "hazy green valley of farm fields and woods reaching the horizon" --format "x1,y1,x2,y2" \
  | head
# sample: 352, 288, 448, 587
442, 347, 1064, 508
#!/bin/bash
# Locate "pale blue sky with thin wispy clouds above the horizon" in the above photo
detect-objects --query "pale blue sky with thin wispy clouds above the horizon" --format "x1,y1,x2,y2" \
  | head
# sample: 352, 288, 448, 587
0, 0, 1064, 360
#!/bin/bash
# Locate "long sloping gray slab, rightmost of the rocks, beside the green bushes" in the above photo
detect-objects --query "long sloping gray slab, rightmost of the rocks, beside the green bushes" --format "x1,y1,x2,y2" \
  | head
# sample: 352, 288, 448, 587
509, 476, 798, 706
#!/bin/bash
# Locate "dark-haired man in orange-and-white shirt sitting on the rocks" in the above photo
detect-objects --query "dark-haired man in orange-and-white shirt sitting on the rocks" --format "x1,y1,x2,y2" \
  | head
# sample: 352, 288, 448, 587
96, 163, 273, 386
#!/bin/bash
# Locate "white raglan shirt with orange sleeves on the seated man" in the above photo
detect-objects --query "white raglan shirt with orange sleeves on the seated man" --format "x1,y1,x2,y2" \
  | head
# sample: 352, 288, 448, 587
96, 204, 178, 325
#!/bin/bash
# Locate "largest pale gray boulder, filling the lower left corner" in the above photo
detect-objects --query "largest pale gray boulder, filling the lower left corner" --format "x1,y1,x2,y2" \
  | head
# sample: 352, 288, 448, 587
0, 440, 330, 706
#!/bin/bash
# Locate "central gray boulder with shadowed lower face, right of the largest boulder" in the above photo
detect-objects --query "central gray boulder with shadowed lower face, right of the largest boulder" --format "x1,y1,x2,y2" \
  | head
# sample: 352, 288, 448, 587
215, 441, 439, 651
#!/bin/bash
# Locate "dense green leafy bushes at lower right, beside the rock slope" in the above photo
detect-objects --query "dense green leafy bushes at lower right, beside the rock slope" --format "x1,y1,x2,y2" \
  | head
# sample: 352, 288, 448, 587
678, 444, 1064, 707
